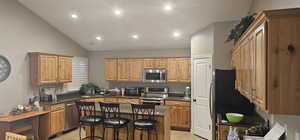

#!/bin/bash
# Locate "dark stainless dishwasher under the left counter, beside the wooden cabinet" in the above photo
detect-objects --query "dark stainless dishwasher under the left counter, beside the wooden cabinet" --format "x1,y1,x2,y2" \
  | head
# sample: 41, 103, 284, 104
65, 102, 79, 131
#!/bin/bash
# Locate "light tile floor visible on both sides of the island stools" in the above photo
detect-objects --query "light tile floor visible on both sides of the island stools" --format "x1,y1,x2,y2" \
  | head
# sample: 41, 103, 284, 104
53, 130, 204, 140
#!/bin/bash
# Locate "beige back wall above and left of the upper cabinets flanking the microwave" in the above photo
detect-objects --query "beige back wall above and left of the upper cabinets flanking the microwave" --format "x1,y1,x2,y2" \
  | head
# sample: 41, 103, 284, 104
89, 48, 190, 91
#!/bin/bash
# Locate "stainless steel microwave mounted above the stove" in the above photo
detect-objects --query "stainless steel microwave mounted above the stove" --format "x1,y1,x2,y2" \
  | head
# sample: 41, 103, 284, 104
144, 69, 167, 83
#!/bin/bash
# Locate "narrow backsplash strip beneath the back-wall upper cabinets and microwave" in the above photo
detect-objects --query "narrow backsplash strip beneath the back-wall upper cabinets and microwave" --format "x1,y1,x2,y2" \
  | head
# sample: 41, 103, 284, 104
109, 82, 191, 92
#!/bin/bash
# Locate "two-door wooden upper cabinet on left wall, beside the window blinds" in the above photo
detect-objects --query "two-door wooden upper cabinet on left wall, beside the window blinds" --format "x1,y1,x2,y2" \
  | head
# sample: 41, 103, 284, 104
30, 53, 72, 85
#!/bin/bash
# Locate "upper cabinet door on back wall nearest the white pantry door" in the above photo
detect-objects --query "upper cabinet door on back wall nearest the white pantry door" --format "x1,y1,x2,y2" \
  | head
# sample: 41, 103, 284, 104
177, 58, 191, 83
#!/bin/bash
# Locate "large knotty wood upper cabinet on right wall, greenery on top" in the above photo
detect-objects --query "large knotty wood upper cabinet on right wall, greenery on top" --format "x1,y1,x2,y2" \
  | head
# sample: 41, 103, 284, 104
232, 9, 300, 115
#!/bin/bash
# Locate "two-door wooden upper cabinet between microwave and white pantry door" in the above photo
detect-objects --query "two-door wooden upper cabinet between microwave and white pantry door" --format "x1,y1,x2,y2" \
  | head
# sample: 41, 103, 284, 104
167, 58, 191, 83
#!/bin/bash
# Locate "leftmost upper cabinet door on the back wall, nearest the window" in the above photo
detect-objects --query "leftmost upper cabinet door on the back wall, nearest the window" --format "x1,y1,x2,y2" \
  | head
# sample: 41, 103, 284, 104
105, 59, 118, 81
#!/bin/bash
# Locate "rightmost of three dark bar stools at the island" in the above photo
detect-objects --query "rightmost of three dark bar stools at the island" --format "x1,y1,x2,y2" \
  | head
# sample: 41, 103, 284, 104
131, 104, 158, 140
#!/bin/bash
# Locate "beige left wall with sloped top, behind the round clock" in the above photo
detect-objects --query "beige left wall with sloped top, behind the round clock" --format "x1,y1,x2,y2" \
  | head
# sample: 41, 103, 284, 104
0, 0, 87, 112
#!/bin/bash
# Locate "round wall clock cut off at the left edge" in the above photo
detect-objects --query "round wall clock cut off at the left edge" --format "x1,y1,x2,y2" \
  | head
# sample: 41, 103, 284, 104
0, 55, 11, 83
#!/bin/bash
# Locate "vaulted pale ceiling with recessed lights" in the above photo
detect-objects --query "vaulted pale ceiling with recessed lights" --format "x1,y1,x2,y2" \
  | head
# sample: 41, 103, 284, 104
19, 0, 251, 50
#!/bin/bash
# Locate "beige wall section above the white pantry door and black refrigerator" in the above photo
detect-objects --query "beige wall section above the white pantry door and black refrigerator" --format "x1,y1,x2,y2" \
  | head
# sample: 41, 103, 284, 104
191, 21, 236, 69
